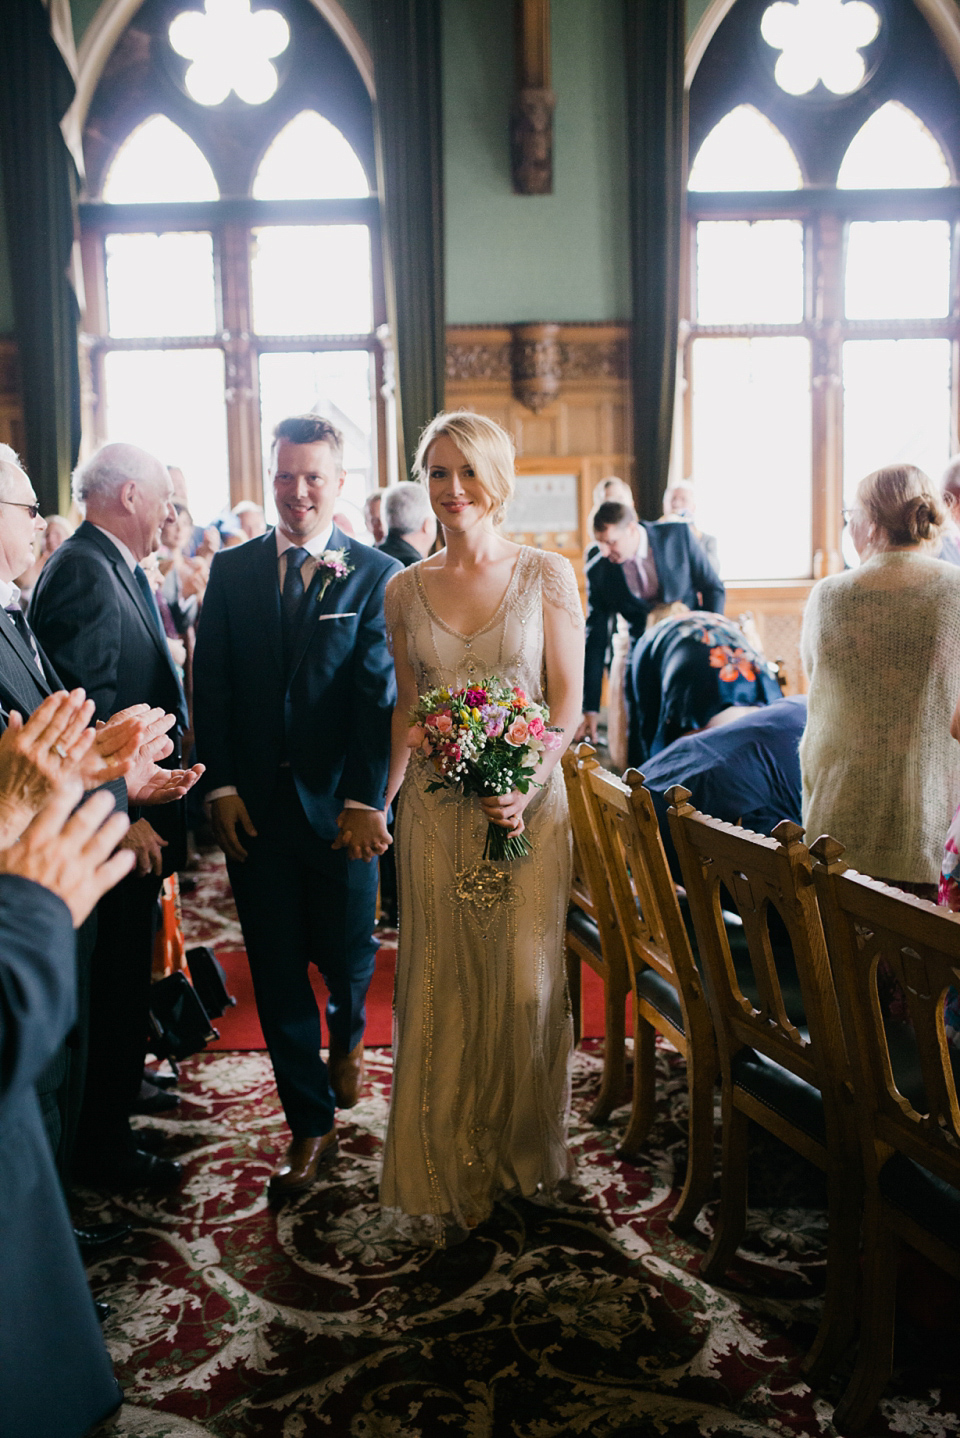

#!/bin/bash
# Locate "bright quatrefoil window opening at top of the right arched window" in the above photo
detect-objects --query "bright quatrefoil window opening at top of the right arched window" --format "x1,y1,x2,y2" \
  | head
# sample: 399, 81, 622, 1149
760, 0, 880, 95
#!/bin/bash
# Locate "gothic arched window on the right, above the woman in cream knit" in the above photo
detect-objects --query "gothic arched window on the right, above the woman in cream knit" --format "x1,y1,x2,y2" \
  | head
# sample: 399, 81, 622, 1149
683, 0, 960, 582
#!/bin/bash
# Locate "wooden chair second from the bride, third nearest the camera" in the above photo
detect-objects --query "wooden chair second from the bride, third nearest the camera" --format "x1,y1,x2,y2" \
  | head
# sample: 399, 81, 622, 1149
578, 754, 719, 1232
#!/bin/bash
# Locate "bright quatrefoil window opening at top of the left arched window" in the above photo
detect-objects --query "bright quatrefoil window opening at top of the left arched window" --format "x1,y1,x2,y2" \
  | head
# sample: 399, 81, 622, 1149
168, 0, 290, 105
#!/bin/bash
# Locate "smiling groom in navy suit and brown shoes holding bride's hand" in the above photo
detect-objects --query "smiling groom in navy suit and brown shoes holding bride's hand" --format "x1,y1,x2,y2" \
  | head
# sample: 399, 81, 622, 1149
194, 414, 400, 1196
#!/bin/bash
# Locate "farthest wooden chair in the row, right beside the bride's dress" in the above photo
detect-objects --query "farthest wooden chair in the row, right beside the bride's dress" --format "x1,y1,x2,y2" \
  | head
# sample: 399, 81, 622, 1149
562, 743, 628, 1123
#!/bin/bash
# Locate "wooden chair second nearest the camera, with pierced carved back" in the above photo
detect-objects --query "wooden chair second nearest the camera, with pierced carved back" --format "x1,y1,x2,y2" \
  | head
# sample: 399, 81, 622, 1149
667, 787, 862, 1379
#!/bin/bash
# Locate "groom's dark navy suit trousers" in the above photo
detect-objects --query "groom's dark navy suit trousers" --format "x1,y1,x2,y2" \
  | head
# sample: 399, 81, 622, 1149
227, 768, 379, 1137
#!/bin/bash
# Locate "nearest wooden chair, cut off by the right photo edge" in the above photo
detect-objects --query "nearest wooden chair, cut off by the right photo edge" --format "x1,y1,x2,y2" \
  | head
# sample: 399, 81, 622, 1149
812, 837, 960, 1432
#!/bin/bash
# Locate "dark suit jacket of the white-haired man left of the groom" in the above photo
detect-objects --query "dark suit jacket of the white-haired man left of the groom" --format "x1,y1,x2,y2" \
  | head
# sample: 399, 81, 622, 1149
30, 521, 187, 874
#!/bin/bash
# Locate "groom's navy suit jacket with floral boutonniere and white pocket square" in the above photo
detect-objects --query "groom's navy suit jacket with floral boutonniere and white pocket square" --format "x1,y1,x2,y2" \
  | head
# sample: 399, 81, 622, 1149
194, 526, 400, 838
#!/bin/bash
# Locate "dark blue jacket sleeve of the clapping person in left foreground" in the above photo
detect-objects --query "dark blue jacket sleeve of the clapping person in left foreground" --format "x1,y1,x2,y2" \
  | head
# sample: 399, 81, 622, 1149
0, 874, 121, 1438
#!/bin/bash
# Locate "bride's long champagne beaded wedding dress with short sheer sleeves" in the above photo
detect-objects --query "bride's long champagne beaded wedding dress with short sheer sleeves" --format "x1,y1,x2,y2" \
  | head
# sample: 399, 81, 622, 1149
381, 548, 583, 1244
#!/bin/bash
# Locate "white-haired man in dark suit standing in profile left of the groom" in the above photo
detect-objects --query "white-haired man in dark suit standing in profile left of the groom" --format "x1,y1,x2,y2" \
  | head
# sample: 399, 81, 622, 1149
30, 444, 201, 1188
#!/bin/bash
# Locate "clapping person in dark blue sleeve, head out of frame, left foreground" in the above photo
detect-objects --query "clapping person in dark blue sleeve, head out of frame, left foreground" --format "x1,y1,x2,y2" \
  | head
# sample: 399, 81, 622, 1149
0, 784, 132, 1438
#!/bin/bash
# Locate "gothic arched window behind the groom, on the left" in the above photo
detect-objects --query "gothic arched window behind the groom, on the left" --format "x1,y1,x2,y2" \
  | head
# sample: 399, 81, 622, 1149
80, 0, 387, 528
